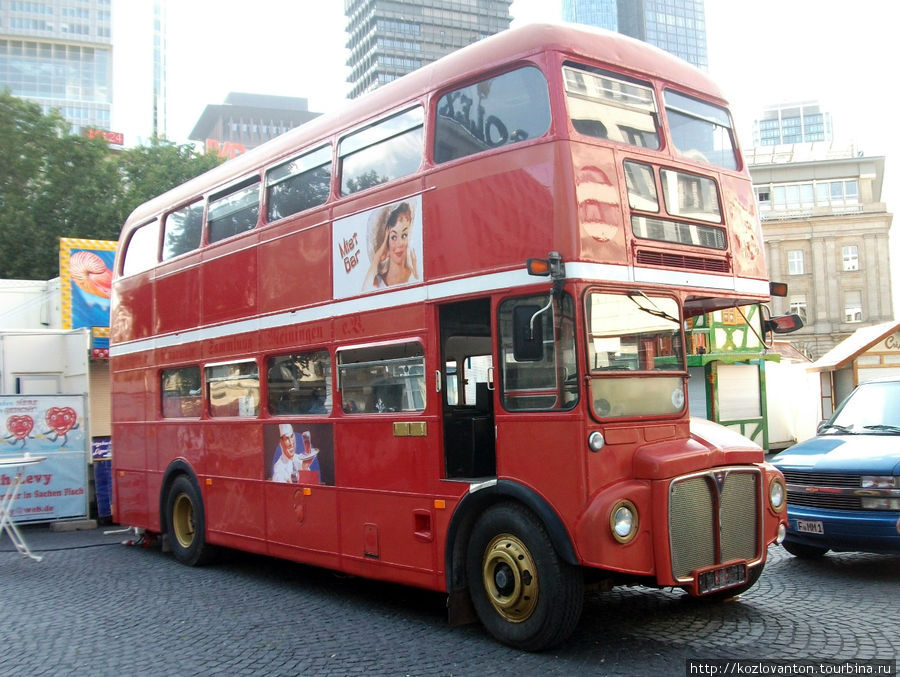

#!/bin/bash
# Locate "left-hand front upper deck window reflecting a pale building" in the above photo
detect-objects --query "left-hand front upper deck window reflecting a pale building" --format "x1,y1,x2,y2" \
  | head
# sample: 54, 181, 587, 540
563, 65, 659, 150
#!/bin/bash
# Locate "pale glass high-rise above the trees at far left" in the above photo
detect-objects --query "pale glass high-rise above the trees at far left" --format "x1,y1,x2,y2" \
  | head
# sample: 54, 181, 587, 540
0, 0, 112, 131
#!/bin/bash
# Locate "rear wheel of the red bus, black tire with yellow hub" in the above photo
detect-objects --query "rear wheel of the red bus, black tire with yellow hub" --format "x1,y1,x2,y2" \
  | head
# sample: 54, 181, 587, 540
166, 475, 215, 566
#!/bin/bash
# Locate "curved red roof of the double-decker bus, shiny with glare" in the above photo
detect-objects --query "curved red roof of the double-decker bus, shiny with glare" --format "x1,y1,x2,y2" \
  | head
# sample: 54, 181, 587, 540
123, 24, 725, 233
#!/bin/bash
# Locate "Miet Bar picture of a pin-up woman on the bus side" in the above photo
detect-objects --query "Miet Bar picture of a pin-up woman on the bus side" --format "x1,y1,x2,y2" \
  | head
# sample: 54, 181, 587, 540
333, 195, 422, 298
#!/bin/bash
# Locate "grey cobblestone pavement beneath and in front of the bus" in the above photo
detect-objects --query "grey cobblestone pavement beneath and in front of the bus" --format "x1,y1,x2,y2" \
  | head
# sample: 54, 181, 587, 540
0, 526, 900, 677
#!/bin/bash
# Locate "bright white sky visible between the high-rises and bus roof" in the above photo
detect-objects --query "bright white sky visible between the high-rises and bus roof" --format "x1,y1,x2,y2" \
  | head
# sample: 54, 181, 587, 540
112, 0, 900, 219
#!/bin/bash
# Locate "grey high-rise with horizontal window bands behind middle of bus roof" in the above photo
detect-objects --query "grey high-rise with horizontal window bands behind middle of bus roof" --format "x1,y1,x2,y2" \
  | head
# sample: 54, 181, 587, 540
344, 0, 512, 99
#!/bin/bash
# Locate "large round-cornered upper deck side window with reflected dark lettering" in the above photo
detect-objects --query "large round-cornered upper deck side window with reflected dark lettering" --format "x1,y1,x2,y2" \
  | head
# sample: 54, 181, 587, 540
434, 66, 550, 163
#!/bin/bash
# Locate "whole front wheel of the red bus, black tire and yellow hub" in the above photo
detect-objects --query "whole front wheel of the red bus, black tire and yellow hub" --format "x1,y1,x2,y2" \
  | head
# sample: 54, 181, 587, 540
466, 503, 584, 651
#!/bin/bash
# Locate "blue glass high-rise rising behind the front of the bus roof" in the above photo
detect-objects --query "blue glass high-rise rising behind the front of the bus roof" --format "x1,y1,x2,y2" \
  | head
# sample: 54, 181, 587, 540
562, 0, 709, 69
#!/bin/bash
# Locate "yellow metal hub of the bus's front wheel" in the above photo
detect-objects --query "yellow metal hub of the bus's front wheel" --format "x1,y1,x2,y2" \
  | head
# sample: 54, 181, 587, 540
481, 534, 539, 623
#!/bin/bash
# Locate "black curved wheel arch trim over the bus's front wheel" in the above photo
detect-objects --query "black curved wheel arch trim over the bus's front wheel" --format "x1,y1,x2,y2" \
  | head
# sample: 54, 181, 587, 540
444, 480, 580, 622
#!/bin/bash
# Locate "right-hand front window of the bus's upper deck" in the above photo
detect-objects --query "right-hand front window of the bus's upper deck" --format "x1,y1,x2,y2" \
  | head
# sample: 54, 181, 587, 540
664, 89, 738, 169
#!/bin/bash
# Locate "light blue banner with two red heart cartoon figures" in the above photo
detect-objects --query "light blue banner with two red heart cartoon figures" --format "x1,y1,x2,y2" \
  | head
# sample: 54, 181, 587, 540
0, 395, 90, 522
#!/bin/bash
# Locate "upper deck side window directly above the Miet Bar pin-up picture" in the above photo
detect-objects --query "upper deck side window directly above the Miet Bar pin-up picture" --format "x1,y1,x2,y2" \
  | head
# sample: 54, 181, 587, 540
339, 107, 425, 195
